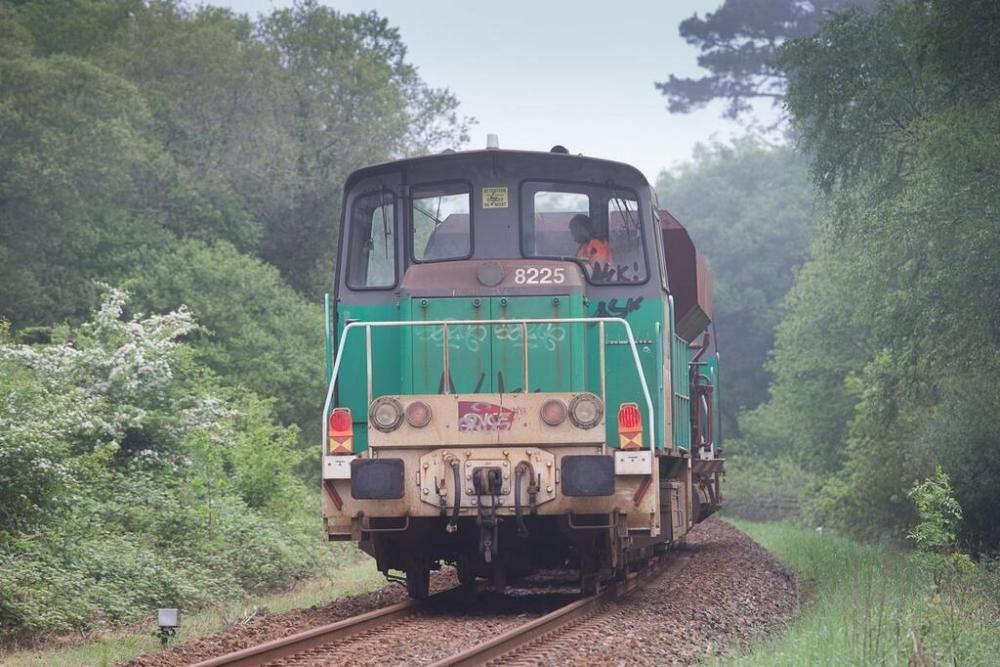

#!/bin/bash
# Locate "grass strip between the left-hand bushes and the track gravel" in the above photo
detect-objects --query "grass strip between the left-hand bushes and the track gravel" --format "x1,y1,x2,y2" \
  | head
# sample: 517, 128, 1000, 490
0, 557, 385, 667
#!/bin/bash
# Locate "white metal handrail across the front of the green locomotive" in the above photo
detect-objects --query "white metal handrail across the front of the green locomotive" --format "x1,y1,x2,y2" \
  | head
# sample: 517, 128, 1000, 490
323, 317, 656, 454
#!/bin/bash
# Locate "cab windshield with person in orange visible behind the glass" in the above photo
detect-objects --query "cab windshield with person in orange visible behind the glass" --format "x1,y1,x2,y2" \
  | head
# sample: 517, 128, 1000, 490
521, 181, 647, 284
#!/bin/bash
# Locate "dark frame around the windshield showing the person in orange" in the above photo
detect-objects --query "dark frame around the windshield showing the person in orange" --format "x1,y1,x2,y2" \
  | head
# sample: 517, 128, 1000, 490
518, 177, 659, 287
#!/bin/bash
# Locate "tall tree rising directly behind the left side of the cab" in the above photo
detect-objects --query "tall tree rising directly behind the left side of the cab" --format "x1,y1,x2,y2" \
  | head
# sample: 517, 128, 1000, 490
250, 0, 468, 296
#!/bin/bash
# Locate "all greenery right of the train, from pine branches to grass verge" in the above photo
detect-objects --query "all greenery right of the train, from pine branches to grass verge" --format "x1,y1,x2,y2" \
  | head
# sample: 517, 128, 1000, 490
658, 0, 1000, 665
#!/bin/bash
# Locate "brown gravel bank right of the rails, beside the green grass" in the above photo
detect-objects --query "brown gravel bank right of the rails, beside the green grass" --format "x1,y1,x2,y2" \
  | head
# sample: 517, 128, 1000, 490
504, 519, 798, 666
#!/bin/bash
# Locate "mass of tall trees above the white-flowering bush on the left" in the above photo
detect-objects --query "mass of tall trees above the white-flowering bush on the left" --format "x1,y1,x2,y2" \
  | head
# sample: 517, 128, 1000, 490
0, 0, 468, 326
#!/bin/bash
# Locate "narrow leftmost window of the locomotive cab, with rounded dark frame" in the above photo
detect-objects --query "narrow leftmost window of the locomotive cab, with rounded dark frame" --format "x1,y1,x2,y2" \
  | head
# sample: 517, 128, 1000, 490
347, 191, 396, 289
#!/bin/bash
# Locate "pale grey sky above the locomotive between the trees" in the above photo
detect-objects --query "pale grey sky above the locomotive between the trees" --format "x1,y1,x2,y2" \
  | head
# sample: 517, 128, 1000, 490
217, 0, 744, 182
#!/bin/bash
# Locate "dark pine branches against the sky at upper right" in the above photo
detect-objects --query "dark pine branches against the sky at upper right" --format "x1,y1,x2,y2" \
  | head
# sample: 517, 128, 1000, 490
655, 0, 873, 119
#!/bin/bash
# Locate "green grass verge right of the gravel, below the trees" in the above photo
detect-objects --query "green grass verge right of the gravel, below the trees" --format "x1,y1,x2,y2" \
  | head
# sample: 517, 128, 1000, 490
726, 518, 1000, 666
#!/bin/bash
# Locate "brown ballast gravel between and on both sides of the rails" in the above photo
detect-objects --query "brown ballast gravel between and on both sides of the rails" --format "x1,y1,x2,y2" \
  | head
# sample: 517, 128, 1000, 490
128, 518, 799, 667
